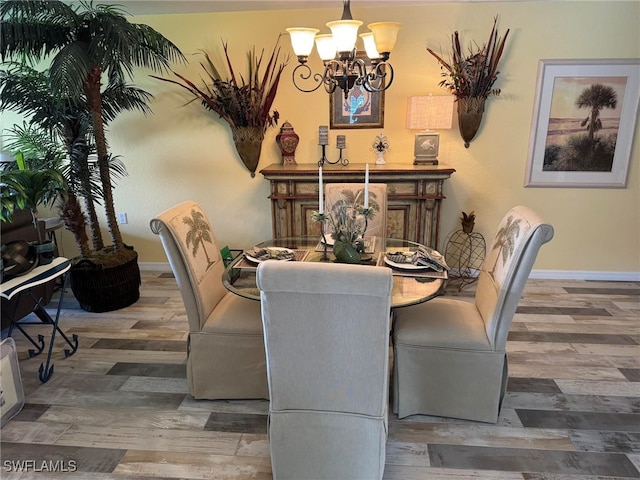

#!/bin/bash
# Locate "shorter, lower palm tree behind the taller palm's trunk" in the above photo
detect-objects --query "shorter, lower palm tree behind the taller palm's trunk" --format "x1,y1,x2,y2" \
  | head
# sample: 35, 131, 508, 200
0, 63, 145, 258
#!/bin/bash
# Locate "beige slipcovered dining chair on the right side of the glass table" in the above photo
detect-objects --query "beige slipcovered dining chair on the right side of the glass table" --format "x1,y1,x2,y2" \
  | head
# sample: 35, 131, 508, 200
393, 207, 553, 423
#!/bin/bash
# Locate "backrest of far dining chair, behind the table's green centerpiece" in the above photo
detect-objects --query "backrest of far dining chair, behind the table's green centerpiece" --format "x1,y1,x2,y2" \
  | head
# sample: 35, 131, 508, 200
324, 183, 388, 238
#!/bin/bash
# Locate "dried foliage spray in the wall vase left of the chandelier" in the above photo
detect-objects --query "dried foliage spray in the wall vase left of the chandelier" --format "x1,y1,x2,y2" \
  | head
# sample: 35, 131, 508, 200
152, 37, 289, 132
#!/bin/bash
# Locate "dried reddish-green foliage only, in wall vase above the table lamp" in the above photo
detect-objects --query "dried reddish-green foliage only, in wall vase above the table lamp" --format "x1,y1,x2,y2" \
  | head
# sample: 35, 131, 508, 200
427, 17, 509, 98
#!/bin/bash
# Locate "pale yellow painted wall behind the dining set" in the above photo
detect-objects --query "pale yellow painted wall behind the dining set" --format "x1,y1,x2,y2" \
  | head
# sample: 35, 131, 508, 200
2, 1, 640, 276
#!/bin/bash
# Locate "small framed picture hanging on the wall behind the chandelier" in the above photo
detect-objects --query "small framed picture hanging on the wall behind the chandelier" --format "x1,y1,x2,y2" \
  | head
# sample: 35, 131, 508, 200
329, 52, 384, 130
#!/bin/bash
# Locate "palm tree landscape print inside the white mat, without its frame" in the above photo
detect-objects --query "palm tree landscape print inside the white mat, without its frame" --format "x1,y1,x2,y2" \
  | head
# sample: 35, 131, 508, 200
542, 77, 627, 172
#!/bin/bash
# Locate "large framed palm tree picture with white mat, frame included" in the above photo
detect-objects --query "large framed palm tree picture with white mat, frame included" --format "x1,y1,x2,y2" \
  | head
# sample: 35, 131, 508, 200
524, 59, 640, 188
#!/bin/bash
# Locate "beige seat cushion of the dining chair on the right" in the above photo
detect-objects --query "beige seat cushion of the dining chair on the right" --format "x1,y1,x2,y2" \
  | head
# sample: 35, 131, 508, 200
394, 298, 492, 351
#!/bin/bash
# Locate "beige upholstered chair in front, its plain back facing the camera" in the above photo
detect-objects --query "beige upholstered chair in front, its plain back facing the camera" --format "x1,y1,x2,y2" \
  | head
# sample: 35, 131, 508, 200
257, 261, 392, 480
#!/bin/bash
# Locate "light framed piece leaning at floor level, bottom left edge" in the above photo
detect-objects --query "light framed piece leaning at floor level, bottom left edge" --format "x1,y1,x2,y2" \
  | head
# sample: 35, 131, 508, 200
0, 337, 24, 427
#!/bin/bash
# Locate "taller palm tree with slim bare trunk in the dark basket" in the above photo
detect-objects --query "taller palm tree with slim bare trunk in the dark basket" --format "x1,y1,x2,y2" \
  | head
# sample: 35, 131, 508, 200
0, 0, 184, 308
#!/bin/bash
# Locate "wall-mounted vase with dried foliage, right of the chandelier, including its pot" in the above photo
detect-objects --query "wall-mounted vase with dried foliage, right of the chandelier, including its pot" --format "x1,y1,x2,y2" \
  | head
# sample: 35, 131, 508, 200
427, 17, 509, 147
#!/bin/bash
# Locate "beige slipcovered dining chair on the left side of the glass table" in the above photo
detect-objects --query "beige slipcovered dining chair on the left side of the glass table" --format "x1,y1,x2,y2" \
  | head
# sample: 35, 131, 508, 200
151, 201, 268, 400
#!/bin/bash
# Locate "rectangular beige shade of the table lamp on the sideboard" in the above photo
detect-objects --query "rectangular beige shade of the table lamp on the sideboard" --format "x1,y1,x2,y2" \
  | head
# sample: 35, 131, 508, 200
407, 95, 454, 130
